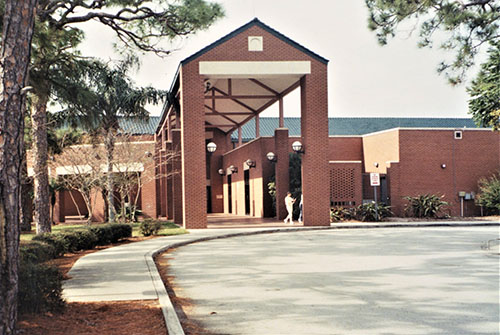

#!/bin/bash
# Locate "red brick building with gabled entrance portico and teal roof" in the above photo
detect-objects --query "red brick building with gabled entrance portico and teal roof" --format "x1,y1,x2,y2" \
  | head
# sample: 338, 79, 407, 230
48, 19, 500, 228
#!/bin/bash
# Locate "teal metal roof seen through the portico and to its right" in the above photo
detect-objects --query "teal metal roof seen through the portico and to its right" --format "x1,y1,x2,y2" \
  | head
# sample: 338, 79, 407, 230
231, 117, 478, 142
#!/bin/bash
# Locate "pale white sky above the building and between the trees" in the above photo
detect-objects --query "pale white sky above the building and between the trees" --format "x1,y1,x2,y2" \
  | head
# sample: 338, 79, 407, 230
81, 0, 474, 118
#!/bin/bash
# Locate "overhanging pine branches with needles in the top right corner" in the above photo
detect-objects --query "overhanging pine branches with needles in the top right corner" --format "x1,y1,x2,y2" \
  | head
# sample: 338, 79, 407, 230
365, 0, 500, 84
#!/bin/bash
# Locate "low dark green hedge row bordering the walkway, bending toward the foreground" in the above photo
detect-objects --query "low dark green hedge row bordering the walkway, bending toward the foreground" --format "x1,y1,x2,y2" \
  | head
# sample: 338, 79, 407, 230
18, 224, 132, 313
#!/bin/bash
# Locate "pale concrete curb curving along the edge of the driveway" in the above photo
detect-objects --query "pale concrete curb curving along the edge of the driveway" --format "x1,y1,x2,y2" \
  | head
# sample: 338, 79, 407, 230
144, 222, 500, 335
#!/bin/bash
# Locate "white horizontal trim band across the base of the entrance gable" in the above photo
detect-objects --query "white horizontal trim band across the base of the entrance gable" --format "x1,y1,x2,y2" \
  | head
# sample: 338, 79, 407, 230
199, 61, 311, 78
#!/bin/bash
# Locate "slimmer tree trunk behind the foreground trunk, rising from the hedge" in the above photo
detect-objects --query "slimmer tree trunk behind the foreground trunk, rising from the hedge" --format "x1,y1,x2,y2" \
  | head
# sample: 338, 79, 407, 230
31, 96, 52, 234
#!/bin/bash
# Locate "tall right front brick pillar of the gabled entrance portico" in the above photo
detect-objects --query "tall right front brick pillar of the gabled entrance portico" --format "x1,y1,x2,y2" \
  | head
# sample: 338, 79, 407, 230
300, 67, 330, 226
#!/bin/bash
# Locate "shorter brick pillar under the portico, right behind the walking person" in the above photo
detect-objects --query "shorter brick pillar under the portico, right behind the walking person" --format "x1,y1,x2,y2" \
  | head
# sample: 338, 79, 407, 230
274, 128, 290, 220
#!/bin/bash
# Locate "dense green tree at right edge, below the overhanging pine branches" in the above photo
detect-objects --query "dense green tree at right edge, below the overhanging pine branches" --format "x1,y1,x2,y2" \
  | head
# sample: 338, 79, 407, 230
467, 41, 500, 130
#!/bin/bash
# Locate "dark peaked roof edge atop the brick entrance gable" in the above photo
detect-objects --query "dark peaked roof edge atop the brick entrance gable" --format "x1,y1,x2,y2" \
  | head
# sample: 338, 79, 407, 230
181, 18, 328, 65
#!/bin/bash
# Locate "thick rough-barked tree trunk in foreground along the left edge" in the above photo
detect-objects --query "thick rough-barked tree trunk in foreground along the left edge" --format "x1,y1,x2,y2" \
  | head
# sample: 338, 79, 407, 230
0, 0, 37, 335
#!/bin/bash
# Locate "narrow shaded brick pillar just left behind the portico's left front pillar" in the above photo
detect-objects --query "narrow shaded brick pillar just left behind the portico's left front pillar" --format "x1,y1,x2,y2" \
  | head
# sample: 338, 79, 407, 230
172, 129, 182, 226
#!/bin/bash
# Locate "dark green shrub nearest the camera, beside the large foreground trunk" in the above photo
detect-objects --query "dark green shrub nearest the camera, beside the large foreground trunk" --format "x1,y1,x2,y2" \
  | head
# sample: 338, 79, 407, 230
18, 261, 64, 313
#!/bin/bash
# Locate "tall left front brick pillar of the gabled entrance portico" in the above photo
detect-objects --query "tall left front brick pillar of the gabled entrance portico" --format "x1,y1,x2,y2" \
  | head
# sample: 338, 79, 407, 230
181, 67, 207, 229
